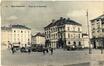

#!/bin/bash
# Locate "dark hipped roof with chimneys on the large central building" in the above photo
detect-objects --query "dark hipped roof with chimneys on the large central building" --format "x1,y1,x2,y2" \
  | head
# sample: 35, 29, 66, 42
45, 17, 81, 28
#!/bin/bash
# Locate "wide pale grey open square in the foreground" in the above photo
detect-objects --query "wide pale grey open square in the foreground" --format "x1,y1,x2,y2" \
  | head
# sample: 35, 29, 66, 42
1, 49, 104, 66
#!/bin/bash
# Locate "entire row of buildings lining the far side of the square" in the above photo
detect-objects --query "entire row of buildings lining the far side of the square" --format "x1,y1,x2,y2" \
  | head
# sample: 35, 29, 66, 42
1, 15, 104, 48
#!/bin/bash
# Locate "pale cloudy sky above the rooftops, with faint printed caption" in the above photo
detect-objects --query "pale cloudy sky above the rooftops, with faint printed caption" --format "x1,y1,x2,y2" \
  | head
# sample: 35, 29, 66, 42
1, 1, 104, 34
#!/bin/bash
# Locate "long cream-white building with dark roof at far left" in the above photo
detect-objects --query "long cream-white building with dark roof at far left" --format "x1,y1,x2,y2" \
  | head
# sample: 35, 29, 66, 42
1, 25, 31, 47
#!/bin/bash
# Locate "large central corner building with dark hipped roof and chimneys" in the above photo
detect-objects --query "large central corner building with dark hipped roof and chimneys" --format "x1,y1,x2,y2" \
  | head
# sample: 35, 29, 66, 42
44, 17, 82, 48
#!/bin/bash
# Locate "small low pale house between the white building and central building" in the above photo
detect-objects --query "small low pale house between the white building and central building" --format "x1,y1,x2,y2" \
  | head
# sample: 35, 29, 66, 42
32, 32, 45, 45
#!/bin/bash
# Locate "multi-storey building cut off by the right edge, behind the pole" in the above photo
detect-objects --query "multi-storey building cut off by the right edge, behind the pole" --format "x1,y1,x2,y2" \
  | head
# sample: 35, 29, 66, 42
91, 14, 104, 48
